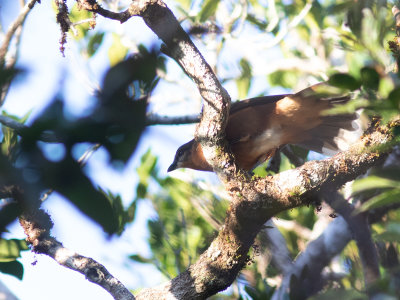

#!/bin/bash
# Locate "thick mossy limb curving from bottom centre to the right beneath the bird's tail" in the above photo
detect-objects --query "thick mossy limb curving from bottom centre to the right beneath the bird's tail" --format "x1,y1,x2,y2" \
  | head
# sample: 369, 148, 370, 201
137, 122, 400, 299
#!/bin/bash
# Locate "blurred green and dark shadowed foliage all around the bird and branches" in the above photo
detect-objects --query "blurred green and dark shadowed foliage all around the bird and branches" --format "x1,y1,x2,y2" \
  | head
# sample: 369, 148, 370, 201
0, 0, 400, 299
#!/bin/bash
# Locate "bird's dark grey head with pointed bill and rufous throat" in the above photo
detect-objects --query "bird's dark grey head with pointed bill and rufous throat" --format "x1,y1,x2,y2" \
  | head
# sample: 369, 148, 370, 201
168, 140, 212, 172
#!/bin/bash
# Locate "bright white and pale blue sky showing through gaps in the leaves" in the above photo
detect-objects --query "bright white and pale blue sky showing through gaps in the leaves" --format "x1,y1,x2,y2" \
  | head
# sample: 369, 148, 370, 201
0, 0, 285, 300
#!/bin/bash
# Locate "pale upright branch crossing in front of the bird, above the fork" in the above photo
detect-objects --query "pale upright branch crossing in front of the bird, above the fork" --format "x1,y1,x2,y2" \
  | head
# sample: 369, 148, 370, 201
78, 0, 236, 176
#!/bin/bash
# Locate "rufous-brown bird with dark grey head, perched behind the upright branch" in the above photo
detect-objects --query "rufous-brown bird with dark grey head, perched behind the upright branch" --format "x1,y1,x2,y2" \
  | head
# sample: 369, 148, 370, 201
168, 82, 361, 172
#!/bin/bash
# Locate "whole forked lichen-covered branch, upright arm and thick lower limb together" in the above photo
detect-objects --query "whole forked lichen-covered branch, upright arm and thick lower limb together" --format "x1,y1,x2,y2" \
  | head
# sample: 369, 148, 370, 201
69, 0, 399, 299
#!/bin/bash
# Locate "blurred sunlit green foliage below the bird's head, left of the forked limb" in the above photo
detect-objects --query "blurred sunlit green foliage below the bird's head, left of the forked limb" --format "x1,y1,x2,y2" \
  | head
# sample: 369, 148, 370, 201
131, 151, 227, 278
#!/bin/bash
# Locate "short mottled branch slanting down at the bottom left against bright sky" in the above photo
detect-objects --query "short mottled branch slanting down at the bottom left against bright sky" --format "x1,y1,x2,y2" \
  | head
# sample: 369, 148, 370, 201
20, 209, 135, 300
